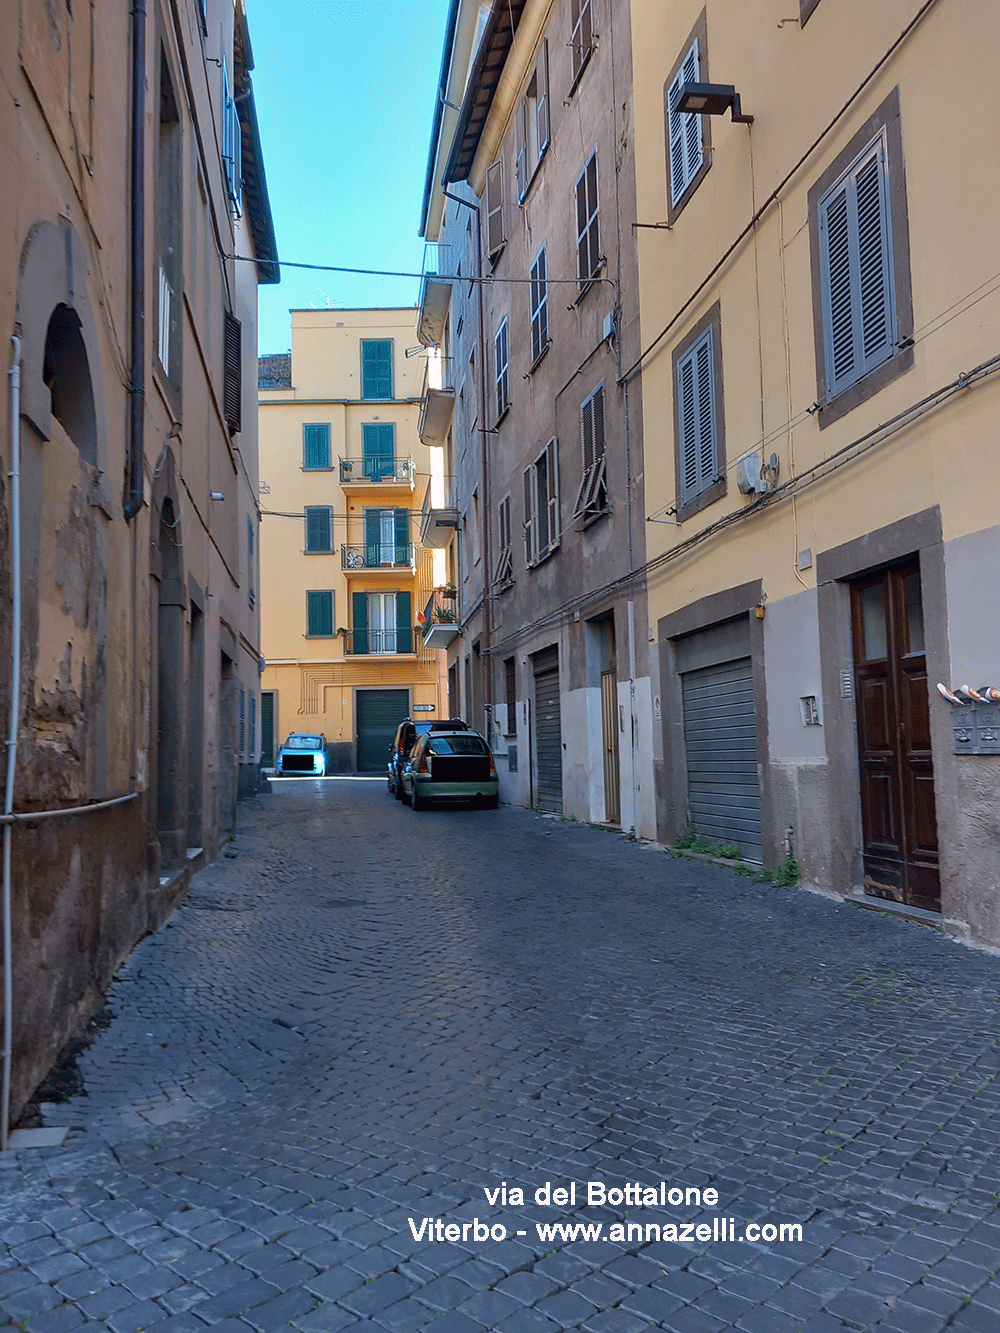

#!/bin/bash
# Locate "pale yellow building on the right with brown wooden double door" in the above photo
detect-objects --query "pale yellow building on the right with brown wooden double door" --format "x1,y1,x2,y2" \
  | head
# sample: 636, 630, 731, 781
634, 0, 1000, 944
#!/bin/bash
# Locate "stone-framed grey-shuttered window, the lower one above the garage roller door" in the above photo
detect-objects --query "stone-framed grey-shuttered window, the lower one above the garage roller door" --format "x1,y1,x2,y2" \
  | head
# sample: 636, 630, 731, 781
673, 303, 725, 521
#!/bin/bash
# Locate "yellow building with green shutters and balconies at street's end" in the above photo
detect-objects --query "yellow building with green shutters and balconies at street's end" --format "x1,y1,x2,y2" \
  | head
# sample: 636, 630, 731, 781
259, 309, 447, 773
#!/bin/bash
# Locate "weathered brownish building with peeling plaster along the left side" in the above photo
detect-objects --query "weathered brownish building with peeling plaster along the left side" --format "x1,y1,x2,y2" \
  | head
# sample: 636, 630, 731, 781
0, 0, 277, 1134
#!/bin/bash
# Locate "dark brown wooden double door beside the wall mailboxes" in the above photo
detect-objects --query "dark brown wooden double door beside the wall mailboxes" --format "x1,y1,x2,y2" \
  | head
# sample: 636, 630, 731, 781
851, 561, 941, 912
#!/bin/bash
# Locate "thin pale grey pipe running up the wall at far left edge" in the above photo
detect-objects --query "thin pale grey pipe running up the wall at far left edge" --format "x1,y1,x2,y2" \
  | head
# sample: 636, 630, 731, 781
0, 337, 21, 1153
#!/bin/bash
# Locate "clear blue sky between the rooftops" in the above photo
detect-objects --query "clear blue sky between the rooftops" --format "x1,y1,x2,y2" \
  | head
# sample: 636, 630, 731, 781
247, 0, 448, 352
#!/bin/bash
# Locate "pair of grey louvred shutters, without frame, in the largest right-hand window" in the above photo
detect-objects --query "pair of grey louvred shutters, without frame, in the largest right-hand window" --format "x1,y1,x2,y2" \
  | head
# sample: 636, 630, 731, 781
819, 137, 896, 399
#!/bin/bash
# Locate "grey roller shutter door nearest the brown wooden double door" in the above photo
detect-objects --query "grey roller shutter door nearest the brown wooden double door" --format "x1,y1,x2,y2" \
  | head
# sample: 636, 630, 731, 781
681, 657, 760, 860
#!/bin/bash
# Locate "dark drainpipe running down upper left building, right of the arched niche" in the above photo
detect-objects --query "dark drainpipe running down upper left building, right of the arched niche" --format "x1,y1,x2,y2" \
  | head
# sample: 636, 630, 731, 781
123, 0, 145, 523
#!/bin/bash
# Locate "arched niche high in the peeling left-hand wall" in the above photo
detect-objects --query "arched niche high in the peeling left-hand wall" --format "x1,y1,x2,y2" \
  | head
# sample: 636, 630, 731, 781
17, 219, 113, 517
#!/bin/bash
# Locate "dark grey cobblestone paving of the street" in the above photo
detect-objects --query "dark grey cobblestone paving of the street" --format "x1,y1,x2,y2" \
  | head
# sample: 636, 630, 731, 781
0, 780, 1000, 1333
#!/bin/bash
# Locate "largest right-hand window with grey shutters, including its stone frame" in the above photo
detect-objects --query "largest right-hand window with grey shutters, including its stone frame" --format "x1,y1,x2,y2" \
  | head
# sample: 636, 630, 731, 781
808, 89, 913, 429
